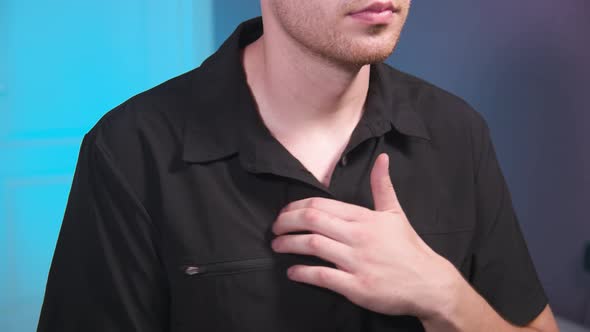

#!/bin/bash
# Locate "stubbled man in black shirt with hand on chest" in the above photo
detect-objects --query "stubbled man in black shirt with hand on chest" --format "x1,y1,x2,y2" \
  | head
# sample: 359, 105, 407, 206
39, 0, 557, 331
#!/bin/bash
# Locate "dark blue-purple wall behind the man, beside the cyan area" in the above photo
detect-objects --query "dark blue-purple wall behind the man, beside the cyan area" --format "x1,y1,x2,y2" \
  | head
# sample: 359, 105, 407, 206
214, 0, 590, 326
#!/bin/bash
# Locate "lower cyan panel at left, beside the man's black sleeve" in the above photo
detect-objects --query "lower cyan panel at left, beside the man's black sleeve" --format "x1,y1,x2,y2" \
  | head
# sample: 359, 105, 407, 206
0, 182, 71, 331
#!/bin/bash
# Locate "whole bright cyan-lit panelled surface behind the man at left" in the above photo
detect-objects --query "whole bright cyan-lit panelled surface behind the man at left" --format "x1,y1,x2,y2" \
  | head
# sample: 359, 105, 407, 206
0, 0, 214, 332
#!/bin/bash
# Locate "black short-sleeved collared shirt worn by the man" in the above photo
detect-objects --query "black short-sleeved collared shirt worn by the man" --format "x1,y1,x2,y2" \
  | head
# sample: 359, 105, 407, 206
39, 18, 547, 332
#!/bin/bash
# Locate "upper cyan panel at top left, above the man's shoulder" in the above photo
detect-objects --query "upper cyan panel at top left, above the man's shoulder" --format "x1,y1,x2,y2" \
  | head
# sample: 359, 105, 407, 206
2, 0, 212, 139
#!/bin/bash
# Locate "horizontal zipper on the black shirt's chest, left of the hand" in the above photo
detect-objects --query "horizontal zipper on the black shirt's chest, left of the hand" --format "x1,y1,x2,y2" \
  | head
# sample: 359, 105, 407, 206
182, 258, 275, 276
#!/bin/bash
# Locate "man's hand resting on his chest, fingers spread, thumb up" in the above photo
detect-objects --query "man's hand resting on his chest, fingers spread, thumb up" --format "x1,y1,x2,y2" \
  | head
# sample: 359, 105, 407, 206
272, 154, 461, 319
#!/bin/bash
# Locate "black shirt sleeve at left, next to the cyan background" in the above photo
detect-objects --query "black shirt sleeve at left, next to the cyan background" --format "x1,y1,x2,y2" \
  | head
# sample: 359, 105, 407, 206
37, 131, 168, 332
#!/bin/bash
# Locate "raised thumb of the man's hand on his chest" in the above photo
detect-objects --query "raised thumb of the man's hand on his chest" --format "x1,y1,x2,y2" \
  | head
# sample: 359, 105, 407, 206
371, 153, 400, 211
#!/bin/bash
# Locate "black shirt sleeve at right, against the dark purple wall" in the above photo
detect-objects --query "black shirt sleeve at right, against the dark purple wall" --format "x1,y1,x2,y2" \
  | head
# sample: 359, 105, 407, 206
470, 114, 548, 326
